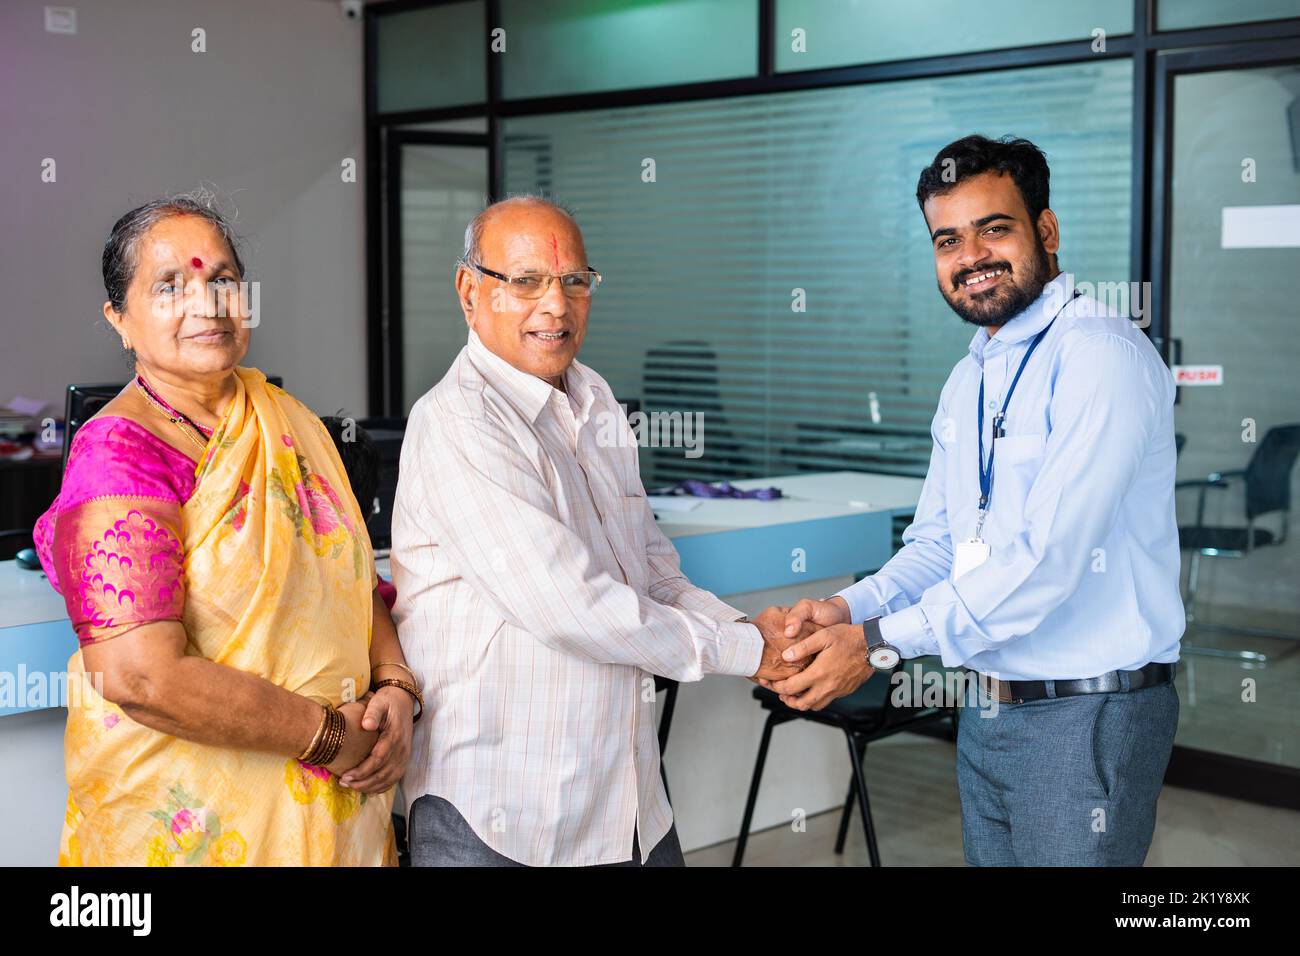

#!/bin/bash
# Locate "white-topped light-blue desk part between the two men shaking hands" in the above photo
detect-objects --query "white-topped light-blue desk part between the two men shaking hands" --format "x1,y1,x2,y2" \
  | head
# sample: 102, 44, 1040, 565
631, 471, 922, 851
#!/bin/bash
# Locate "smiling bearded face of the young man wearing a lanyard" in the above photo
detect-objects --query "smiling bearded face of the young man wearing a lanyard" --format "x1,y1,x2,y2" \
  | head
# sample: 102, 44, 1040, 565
924, 172, 1061, 334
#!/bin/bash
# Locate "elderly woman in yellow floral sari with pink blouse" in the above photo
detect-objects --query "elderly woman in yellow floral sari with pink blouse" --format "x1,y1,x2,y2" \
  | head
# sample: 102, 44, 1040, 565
36, 199, 423, 865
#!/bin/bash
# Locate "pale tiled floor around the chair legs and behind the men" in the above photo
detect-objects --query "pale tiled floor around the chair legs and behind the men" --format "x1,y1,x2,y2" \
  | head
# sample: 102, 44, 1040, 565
686, 734, 1300, 866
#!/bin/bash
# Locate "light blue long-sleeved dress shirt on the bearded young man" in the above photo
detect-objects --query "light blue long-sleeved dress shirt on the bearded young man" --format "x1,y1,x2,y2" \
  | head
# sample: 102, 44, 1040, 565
840, 273, 1186, 680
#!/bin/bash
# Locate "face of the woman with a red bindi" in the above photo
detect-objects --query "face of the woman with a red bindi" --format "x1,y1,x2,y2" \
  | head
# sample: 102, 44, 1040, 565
104, 216, 250, 381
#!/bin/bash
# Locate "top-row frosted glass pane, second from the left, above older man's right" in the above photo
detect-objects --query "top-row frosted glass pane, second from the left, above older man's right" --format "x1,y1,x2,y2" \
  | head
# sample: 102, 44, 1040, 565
501, 0, 758, 99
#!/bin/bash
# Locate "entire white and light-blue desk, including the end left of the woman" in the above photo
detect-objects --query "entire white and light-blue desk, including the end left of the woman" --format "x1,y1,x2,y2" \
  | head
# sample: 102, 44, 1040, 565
0, 472, 922, 865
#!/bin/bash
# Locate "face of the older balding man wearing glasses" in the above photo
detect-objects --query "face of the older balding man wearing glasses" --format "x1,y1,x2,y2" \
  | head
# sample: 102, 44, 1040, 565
456, 203, 592, 388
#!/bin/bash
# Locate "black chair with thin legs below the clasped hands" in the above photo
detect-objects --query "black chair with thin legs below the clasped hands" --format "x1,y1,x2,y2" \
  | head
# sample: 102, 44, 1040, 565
732, 665, 957, 866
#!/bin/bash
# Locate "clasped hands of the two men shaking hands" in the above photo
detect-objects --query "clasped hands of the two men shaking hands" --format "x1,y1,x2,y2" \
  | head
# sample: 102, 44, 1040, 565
750, 597, 874, 710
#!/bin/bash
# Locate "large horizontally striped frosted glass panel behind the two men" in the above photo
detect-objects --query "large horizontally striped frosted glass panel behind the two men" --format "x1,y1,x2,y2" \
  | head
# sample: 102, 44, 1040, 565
503, 60, 1132, 484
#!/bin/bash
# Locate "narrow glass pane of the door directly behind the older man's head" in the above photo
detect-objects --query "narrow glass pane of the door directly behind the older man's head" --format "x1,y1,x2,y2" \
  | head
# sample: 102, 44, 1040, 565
400, 146, 488, 415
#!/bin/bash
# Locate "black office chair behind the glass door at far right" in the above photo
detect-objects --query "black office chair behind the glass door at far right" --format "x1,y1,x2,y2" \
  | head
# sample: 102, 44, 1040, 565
1174, 424, 1300, 663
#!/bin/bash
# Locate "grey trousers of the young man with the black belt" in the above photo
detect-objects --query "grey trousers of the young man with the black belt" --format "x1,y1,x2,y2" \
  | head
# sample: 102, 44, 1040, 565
957, 683, 1178, 866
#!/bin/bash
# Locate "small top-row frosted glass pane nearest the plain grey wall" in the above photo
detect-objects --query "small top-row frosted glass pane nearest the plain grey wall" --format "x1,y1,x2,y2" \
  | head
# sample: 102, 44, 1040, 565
376, 0, 488, 113
